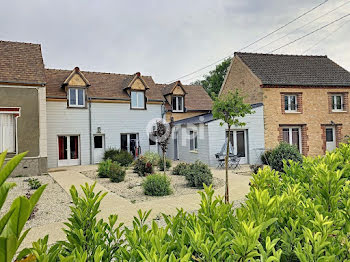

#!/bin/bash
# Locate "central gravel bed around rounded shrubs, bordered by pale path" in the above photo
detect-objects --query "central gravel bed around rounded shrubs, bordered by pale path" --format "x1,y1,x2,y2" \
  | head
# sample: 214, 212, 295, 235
82, 168, 225, 203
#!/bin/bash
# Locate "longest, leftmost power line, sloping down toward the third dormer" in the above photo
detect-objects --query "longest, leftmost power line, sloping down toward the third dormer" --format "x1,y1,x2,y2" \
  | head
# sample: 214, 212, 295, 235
166, 0, 329, 84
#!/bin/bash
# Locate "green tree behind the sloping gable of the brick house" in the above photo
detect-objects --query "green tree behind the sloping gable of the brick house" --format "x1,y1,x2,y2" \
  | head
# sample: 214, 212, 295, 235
193, 57, 232, 99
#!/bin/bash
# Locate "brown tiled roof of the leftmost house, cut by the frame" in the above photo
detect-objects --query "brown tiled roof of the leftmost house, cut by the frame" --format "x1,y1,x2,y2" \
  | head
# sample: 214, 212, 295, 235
0, 41, 45, 85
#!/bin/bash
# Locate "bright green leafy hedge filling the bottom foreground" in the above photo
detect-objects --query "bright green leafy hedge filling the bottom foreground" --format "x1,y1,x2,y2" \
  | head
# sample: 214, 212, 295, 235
21, 144, 350, 262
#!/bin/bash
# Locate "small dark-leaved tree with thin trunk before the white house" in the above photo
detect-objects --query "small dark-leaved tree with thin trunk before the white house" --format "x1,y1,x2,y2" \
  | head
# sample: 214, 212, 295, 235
152, 118, 174, 175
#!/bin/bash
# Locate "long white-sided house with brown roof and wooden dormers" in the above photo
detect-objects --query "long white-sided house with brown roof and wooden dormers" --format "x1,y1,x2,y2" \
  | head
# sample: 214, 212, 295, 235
45, 67, 211, 167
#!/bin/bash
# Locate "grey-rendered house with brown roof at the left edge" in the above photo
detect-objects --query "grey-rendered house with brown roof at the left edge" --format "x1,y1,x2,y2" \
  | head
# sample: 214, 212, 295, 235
0, 41, 47, 175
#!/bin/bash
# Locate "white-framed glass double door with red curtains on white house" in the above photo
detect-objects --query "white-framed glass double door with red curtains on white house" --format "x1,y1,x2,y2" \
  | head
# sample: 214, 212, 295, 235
58, 135, 80, 166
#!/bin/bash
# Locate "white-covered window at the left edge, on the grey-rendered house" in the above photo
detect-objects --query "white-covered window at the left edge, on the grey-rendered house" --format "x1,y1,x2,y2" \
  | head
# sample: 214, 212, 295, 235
0, 114, 16, 153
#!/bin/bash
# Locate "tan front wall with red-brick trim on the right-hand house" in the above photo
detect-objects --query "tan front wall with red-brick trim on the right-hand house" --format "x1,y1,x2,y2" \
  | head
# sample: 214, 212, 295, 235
262, 87, 350, 156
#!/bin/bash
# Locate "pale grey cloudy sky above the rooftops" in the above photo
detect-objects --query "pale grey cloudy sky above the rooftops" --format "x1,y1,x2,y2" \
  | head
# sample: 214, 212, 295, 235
0, 0, 350, 83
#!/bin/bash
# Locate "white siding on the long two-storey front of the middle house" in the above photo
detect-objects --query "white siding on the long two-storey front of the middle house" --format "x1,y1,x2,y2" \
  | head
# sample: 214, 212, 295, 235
47, 102, 161, 167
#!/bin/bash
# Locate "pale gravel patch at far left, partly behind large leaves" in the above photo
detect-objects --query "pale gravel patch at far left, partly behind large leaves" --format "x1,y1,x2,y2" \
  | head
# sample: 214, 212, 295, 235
0, 175, 71, 228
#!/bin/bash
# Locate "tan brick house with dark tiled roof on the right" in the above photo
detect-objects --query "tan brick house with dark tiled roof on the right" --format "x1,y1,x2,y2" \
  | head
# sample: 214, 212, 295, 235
220, 53, 350, 156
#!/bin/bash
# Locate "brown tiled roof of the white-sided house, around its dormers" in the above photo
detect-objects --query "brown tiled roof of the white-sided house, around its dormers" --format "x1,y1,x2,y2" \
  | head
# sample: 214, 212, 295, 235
45, 69, 163, 101
